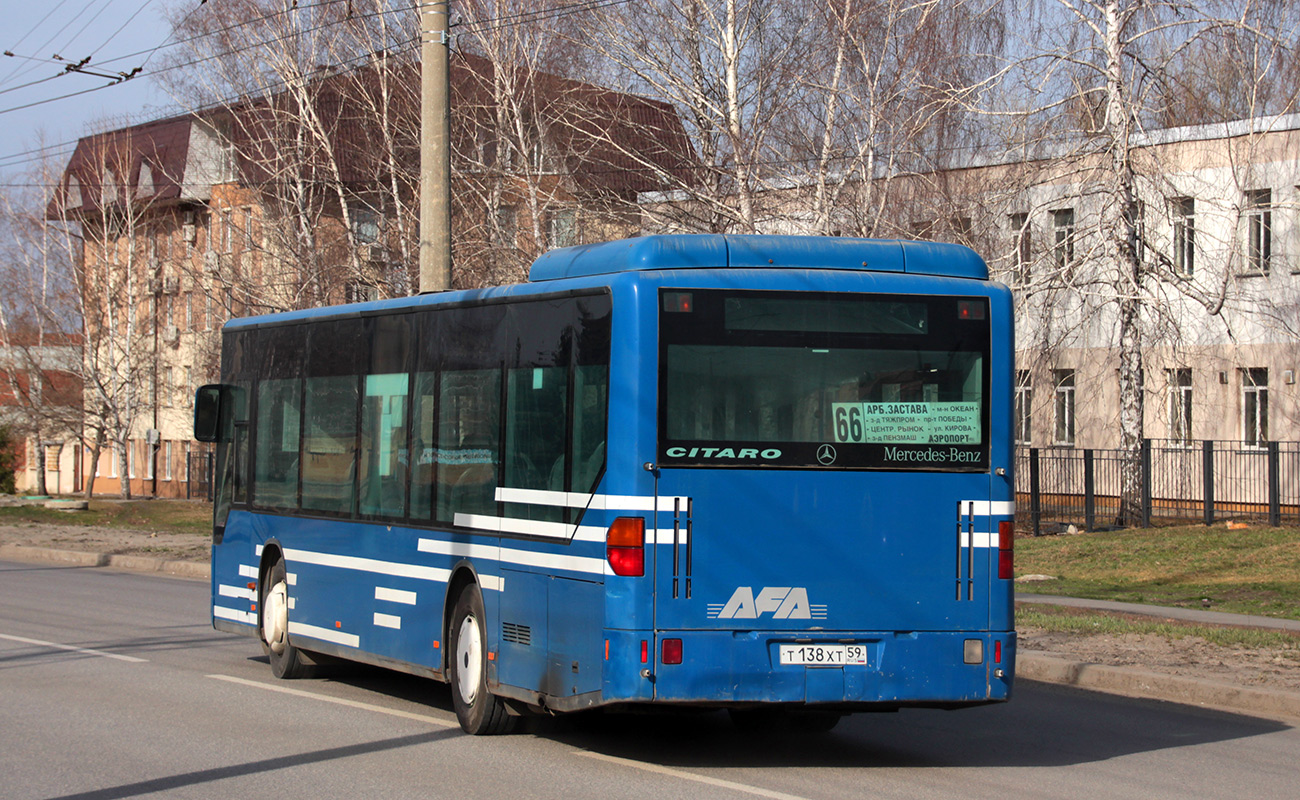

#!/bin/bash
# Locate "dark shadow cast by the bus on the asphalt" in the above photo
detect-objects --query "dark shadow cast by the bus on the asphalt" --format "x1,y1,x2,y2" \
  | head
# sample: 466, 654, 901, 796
269, 665, 1291, 769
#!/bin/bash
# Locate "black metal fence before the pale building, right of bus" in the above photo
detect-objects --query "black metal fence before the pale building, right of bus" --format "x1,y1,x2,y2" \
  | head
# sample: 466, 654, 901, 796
1015, 440, 1300, 535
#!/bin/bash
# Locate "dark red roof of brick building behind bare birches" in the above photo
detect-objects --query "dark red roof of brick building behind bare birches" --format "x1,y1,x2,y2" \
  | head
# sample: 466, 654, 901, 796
48, 53, 693, 217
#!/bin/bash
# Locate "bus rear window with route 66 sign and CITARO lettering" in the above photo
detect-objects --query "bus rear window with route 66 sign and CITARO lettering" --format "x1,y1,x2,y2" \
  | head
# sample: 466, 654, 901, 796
659, 290, 989, 471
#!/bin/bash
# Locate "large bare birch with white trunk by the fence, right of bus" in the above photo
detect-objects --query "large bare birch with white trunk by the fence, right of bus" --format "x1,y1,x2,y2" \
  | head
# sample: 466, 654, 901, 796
967, 0, 1295, 524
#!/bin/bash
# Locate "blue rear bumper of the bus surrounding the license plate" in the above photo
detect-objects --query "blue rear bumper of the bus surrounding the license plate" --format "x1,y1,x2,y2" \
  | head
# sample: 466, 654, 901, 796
603, 631, 1015, 709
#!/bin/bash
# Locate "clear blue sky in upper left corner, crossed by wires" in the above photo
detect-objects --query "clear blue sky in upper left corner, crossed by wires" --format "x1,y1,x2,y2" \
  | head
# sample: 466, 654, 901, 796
0, 0, 178, 182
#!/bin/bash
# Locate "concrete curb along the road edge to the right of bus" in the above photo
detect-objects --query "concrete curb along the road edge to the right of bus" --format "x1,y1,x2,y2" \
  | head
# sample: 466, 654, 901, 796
1015, 650, 1300, 719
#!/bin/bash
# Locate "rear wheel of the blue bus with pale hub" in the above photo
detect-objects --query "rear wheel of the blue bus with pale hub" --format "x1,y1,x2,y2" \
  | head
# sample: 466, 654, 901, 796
447, 584, 515, 736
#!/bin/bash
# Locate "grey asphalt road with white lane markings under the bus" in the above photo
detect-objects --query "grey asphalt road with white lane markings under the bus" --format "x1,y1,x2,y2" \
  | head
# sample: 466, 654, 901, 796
0, 562, 1300, 800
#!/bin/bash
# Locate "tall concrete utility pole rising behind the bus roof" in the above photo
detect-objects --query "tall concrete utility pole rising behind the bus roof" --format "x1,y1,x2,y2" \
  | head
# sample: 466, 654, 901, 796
420, 0, 451, 294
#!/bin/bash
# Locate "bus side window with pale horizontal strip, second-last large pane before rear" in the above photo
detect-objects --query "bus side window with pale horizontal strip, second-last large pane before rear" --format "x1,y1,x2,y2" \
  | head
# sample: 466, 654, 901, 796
434, 369, 501, 523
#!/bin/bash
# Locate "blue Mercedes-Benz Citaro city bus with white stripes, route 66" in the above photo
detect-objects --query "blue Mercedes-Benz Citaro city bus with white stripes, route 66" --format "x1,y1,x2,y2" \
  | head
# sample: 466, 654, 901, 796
195, 234, 1015, 734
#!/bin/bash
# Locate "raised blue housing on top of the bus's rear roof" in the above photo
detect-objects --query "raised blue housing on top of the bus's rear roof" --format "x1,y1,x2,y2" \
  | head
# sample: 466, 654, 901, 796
528, 234, 988, 282
